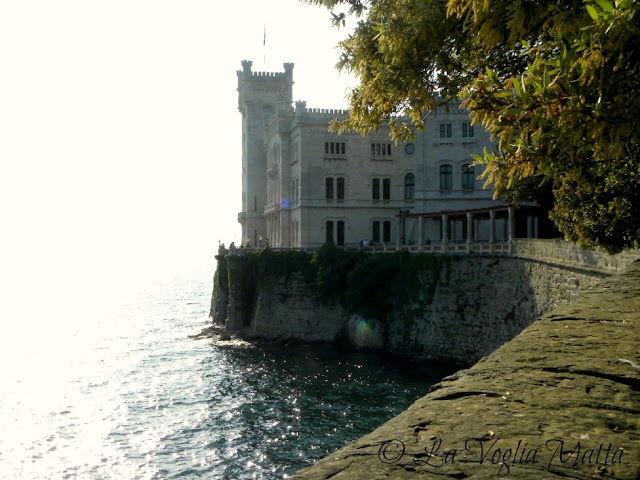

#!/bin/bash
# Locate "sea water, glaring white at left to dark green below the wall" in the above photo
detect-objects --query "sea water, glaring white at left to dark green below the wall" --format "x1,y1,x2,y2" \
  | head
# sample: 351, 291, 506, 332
0, 268, 454, 480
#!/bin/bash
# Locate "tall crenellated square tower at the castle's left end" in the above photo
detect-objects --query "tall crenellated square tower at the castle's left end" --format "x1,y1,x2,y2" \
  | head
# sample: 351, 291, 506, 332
237, 60, 293, 246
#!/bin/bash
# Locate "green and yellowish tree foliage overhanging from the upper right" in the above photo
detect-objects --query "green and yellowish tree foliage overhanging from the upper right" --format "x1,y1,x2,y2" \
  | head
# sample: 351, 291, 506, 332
302, 0, 640, 252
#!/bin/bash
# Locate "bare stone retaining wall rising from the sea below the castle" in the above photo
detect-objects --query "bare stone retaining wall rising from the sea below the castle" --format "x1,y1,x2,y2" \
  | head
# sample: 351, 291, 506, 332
212, 240, 639, 365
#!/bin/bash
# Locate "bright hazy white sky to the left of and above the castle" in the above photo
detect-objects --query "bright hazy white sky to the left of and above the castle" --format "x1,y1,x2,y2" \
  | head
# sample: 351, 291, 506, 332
0, 0, 354, 322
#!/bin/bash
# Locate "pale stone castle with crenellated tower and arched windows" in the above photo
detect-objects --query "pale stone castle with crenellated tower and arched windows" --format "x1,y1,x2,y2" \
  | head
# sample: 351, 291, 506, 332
237, 60, 537, 247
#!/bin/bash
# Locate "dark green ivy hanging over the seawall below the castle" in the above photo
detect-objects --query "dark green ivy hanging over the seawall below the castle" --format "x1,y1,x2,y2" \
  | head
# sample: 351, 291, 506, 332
226, 243, 450, 320
